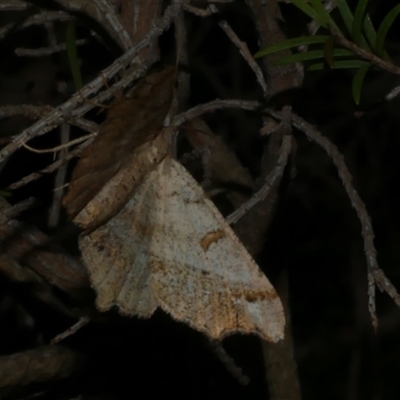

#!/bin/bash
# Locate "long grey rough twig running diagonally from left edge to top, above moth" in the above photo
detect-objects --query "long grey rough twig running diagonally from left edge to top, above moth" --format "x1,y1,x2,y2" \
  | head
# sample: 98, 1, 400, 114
0, 3, 181, 162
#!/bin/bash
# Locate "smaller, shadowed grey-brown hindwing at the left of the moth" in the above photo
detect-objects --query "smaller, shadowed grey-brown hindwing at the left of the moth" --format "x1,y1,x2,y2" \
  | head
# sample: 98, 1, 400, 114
79, 171, 158, 317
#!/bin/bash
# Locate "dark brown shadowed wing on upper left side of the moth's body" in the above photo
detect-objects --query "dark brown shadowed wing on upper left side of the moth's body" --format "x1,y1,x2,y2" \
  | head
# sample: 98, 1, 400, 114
63, 66, 175, 230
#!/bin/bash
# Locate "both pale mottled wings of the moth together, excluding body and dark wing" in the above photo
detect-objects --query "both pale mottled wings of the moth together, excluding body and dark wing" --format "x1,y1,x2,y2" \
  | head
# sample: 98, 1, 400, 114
80, 157, 284, 341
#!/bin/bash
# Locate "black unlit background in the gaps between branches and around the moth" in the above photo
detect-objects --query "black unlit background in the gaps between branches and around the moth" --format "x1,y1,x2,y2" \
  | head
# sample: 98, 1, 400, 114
0, 1, 400, 400
